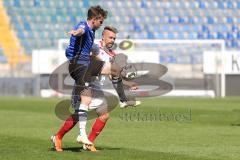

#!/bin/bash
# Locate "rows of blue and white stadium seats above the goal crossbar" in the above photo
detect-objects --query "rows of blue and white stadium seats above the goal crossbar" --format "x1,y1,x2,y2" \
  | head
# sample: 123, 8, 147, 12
1, 0, 240, 62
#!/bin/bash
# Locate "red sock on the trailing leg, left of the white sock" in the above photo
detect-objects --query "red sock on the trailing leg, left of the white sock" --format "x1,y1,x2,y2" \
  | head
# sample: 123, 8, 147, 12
56, 115, 78, 139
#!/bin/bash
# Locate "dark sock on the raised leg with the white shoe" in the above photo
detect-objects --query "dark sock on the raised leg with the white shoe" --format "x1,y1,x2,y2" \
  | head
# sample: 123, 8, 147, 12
112, 77, 127, 102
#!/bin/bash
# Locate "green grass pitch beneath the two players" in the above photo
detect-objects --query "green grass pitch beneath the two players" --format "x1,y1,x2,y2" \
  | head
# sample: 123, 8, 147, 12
0, 97, 240, 160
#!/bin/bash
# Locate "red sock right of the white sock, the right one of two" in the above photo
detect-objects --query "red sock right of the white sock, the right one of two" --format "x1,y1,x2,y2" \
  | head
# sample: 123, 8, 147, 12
88, 118, 106, 142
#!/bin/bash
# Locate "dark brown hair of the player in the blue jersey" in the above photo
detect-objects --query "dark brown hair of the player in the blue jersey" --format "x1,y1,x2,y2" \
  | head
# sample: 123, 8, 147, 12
87, 5, 108, 20
